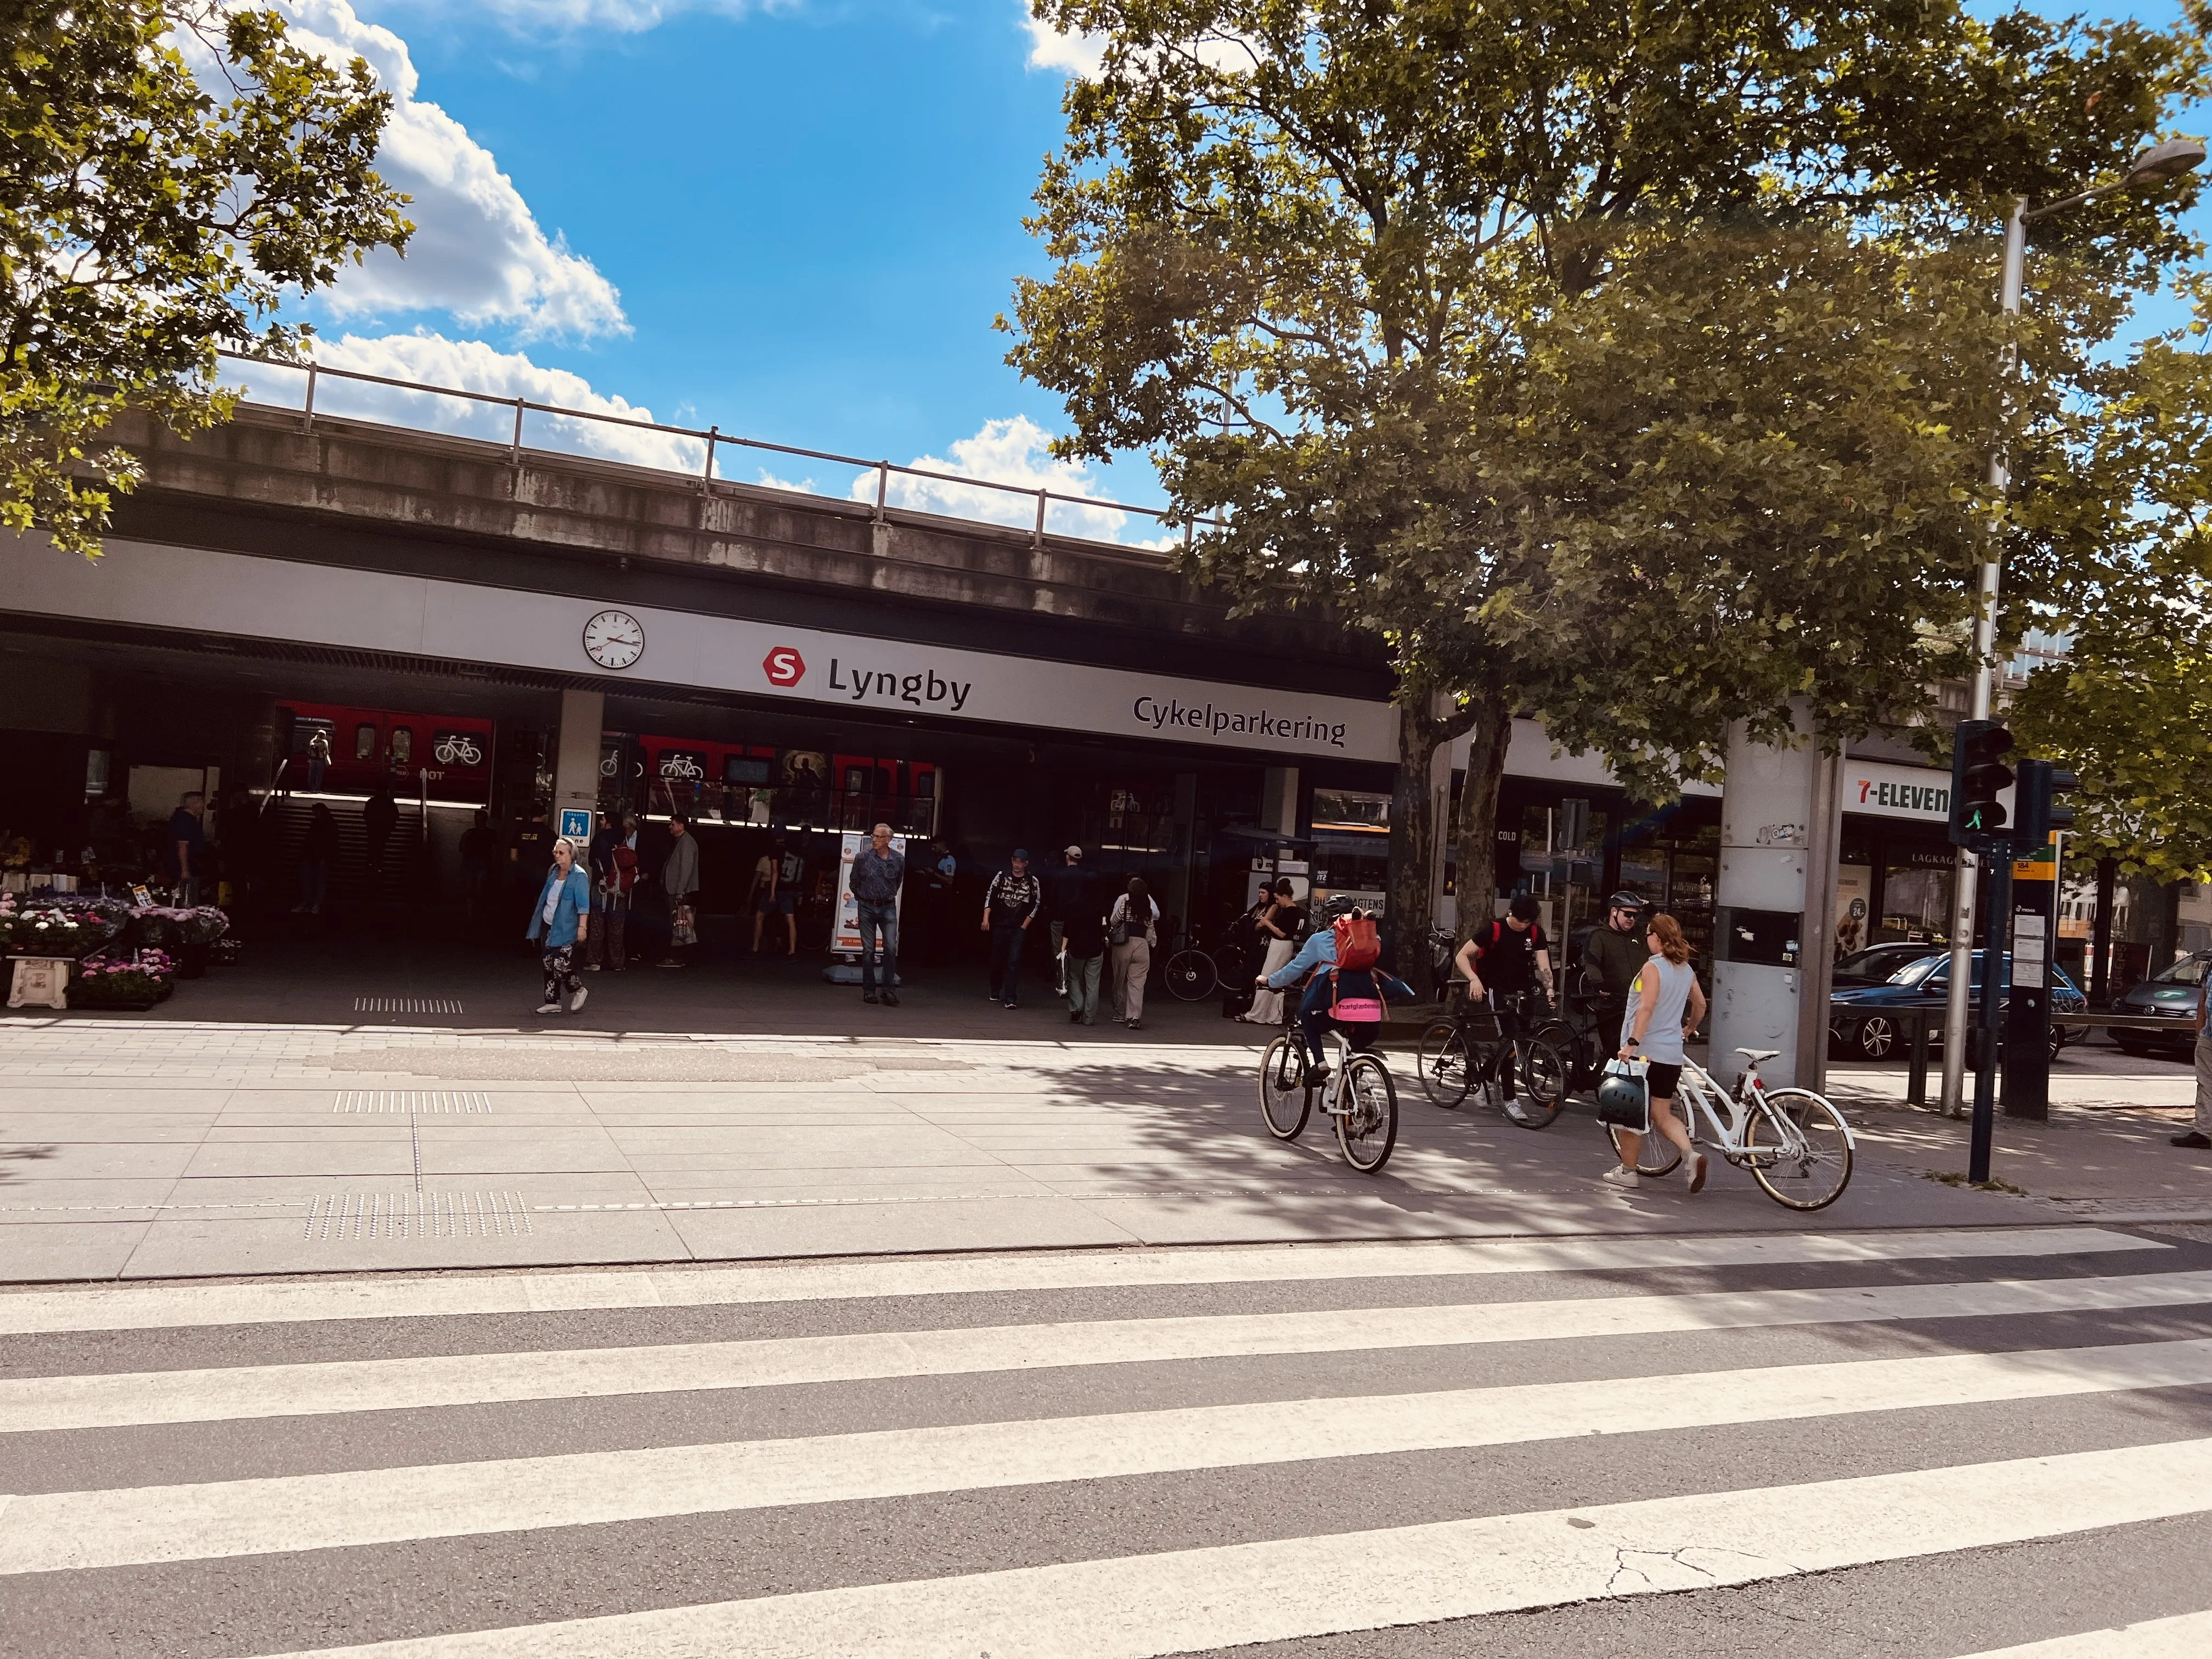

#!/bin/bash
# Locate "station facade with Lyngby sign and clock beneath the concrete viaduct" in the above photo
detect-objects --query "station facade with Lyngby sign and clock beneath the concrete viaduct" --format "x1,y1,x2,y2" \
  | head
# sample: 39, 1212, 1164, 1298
0, 407, 1949, 960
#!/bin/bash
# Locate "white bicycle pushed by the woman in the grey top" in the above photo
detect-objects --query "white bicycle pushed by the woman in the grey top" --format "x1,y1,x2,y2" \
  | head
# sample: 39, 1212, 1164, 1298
1606, 1048, 1858, 1210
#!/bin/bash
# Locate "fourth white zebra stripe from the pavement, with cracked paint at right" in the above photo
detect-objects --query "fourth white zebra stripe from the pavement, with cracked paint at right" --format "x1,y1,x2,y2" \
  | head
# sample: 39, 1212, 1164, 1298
242, 1440, 2212, 1659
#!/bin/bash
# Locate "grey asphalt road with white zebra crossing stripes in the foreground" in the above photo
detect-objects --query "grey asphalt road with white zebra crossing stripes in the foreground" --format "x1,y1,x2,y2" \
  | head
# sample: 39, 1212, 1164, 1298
0, 1228, 2212, 1659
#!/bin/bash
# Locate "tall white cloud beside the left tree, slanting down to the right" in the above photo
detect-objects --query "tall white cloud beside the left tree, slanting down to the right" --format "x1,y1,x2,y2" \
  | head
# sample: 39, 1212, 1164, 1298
253, 0, 630, 341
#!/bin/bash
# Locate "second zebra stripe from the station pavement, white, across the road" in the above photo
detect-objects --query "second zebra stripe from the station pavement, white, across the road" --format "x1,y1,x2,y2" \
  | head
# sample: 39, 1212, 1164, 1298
0, 1272, 2212, 1434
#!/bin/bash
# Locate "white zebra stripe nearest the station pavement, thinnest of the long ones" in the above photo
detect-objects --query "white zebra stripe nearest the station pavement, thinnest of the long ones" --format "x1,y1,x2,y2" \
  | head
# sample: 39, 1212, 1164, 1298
0, 1228, 2172, 1336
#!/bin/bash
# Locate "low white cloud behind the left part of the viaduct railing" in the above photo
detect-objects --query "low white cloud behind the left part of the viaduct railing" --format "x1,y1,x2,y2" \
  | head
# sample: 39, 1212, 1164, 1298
225, 332, 706, 473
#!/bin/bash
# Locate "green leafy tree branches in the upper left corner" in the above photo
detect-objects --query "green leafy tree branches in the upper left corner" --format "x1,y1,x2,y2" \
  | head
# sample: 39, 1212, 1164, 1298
0, 0, 414, 555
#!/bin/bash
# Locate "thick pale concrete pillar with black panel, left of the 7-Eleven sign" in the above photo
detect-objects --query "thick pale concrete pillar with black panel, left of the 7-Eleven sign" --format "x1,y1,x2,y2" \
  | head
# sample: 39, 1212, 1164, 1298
1710, 708, 1843, 1088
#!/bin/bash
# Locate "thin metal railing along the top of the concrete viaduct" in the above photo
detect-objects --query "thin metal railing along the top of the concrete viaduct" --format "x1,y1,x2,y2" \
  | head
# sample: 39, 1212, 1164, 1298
221, 352, 1192, 553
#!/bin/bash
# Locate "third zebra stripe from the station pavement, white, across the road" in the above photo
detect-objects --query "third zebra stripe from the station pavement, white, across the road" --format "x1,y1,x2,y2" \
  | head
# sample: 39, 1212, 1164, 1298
0, 1338, 2212, 1573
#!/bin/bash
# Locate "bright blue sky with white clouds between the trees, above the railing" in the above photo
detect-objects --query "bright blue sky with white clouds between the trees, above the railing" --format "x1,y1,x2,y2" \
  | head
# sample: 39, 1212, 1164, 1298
257, 0, 2203, 535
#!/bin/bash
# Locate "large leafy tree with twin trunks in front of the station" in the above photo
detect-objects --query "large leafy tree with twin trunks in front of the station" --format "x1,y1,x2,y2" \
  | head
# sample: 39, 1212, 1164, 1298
1009, 0, 2203, 973
